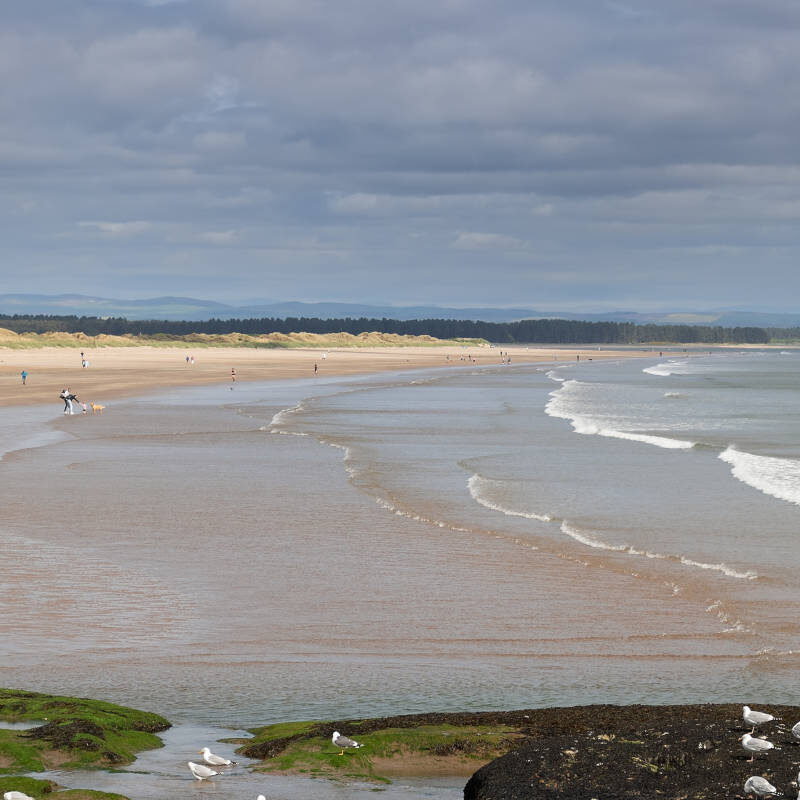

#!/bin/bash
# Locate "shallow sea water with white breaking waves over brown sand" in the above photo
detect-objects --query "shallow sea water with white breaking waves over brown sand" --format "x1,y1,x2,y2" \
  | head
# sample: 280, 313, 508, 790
0, 350, 800, 792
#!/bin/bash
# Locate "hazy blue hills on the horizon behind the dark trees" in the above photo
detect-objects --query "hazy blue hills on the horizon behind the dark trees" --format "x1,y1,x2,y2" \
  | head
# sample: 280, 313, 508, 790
0, 294, 800, 328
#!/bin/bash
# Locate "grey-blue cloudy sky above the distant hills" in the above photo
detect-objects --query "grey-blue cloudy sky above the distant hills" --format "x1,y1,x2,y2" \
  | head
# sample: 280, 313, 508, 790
0, 0, 800, 311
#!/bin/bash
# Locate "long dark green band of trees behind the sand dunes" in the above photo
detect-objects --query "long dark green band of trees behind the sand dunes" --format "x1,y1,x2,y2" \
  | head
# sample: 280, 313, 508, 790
0, 314, 776, 345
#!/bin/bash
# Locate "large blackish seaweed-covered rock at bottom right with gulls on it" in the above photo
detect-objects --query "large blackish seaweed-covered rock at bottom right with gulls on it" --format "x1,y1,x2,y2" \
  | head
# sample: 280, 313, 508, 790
464, 704, 800, 800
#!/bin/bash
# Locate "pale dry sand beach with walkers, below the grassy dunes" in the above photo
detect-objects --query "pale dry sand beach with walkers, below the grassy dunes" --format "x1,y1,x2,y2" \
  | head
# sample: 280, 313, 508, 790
0, 345, 666, 406
